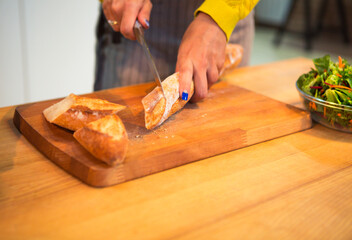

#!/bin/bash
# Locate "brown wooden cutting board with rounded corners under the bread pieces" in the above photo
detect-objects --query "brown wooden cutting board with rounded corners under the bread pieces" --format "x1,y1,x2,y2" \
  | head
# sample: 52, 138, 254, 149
14, 82, 312, 187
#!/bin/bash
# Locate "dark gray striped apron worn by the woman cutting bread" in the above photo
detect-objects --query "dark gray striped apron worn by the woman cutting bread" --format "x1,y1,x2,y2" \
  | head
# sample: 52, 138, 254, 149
94, 0, 254, 90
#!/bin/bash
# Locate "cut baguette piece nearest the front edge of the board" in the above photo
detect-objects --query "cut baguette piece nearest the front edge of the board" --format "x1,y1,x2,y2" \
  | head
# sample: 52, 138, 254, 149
73, 114, 128, 166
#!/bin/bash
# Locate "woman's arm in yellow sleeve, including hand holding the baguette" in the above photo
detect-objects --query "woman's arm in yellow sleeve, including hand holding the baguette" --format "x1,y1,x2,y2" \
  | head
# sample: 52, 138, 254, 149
176, 0, 259, 102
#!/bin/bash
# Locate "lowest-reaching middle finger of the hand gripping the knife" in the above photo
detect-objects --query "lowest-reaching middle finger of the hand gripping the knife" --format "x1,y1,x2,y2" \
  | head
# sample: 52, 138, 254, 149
120, 2, 142, 40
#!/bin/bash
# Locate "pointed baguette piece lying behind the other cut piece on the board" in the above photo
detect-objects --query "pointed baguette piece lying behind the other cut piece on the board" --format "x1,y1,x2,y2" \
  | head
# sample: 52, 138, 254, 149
43, 93, 125, 131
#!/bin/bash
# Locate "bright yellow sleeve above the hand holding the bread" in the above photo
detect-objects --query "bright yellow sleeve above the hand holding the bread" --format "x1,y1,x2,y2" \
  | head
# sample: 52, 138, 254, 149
194, 0, 259, 40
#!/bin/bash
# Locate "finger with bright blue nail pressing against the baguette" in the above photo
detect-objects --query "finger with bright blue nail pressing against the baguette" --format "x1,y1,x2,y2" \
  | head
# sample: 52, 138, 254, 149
176, 61, 193, 101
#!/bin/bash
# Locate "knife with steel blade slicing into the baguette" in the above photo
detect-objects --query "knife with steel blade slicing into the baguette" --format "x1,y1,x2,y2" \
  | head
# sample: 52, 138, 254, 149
133, 20, 165, 97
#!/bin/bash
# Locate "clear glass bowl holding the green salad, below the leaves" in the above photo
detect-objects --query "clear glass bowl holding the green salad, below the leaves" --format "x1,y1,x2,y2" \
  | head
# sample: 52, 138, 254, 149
296, 80, 352, 133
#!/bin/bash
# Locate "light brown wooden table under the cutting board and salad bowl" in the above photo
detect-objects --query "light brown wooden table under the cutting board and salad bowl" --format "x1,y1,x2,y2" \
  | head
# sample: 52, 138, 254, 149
0, 58, 352, 239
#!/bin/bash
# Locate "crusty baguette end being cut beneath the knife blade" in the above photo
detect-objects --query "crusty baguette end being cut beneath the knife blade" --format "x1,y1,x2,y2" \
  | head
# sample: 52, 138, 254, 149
142, 73, 194, 129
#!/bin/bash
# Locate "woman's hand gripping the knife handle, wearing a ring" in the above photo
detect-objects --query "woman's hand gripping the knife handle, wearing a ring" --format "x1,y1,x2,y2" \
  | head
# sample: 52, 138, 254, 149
103, 0, 152, 40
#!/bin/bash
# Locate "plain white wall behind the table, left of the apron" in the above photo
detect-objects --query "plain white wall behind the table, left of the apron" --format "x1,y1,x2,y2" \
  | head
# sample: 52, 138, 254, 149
0, 0, 99, 107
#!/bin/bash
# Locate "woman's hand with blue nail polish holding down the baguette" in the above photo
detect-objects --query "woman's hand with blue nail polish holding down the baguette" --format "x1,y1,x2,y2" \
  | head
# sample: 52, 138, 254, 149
176, 12, 227, 102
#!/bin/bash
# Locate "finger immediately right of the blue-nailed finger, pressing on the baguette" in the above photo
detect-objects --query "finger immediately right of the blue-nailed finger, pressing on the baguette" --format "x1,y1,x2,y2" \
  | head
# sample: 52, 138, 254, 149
191, 63, 208, 102
